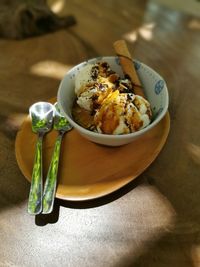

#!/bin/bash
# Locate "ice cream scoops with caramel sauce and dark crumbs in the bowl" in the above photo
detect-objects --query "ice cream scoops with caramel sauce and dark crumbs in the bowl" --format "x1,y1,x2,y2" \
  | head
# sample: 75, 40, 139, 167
72, 61, 152, 135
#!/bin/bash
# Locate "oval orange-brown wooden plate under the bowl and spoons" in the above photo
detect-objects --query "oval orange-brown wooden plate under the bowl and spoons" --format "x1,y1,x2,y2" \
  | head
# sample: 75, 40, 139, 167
15, 100, 170, 201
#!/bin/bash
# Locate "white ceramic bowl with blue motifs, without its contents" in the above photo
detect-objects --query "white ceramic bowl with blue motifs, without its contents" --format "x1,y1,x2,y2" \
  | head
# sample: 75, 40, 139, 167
57, 56, 169, 146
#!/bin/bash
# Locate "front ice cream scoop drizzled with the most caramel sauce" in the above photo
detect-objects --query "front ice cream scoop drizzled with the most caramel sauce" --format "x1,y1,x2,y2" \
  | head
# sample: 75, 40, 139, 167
94, 90, 151, 134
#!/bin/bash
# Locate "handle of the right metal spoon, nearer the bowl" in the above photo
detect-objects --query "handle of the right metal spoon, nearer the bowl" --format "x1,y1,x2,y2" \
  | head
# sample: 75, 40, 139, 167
42, 132, 63, 214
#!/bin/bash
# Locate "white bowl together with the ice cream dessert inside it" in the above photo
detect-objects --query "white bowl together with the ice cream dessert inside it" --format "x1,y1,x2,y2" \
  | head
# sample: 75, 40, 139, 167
57, 42, 169, 146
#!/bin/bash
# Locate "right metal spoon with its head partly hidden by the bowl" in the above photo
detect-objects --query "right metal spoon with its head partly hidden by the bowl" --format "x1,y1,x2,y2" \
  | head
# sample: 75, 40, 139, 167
42, 103, 72, 214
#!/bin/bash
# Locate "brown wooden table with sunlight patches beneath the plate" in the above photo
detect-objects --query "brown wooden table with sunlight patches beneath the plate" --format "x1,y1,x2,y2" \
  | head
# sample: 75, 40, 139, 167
0, 0, 200, 267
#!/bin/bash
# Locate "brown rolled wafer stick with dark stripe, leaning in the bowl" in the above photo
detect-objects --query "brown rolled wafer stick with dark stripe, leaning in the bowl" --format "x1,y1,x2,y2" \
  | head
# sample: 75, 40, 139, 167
113, 40, 145, 97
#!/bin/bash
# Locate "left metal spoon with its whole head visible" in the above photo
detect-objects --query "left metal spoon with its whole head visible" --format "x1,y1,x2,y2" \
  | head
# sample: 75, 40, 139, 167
28, 102, 54, 215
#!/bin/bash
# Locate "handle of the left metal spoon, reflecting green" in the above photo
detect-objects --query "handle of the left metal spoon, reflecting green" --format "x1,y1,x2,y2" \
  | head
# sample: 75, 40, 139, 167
28, 135, 43, 215
